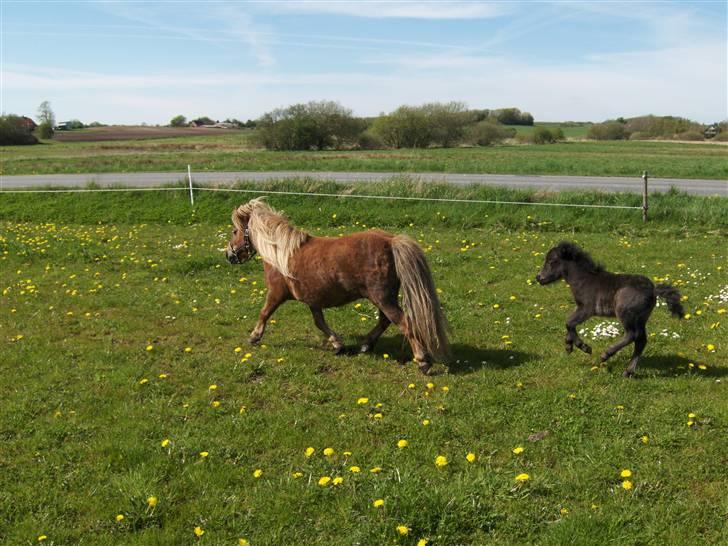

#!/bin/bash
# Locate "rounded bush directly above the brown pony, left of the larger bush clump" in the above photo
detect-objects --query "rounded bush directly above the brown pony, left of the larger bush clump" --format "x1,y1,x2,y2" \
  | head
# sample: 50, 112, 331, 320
257, 101, 365, 150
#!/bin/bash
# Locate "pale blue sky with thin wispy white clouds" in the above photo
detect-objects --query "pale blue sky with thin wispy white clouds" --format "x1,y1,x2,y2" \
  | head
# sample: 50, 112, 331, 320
0, 0, 728, 124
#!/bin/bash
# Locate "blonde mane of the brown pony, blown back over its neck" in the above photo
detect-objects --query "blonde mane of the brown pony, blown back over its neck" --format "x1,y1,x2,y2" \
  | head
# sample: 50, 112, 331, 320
232, 197, 309, 277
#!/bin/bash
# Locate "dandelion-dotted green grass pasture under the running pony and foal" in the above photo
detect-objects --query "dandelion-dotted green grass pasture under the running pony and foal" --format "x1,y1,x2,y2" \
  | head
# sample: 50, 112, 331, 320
0, 182, 728, 545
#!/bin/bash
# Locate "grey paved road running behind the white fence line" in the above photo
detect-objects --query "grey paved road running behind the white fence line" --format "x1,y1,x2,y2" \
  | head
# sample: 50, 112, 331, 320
0, 171, 728, 197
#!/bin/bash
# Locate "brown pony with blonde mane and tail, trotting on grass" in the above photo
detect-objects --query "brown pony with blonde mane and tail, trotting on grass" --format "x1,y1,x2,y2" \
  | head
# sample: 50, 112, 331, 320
226, 198, 449, 374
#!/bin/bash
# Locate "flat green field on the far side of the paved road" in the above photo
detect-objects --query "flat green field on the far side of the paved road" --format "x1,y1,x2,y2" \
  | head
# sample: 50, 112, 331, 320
0, 132, 728, 179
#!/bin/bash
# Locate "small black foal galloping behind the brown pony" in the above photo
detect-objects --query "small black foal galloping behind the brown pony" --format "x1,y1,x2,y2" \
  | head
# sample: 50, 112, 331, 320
536, 242, 684, 377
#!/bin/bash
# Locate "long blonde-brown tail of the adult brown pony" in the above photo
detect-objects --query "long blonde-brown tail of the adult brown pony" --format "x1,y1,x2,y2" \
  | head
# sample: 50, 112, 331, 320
392, 235, 450, 361
